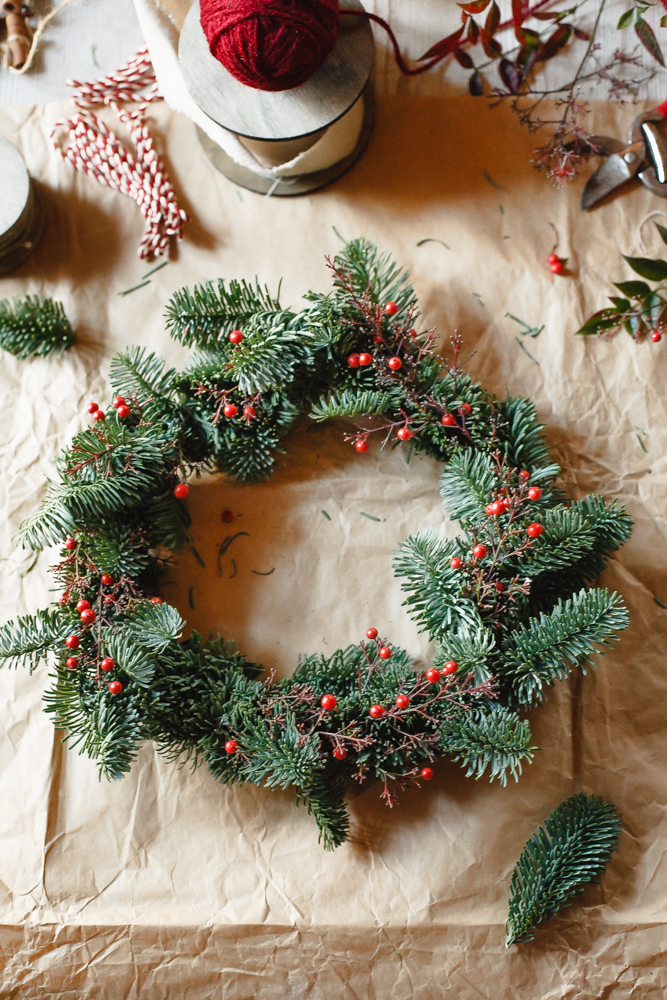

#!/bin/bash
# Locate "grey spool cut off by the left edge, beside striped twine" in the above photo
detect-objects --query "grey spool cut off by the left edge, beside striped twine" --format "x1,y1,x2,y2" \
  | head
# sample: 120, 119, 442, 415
0, 136, 42, 274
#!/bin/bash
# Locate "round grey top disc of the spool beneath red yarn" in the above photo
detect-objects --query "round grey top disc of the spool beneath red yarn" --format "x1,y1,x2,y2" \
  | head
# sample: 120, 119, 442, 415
178, 0, 374, 142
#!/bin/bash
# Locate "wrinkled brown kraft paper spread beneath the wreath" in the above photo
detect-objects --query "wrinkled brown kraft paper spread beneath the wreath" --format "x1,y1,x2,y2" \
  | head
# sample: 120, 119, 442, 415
0, 97, 667, 1000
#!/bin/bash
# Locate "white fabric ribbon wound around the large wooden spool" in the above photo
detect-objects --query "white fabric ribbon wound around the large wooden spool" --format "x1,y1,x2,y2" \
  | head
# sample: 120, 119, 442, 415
134, 0, 363, 179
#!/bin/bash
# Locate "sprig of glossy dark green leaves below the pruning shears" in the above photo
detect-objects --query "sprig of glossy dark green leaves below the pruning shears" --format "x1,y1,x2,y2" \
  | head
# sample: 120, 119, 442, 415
577, 222, 667, 344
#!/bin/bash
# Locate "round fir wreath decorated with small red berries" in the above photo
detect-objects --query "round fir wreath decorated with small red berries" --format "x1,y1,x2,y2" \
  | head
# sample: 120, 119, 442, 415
0, 240, 631, 848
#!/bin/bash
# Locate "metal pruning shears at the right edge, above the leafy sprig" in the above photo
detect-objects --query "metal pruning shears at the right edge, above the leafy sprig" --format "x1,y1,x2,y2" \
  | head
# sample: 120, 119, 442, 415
581, 101, 667, 209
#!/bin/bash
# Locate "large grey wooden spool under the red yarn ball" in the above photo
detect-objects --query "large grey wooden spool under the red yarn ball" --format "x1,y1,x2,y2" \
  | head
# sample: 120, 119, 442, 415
178, 0, 374, 197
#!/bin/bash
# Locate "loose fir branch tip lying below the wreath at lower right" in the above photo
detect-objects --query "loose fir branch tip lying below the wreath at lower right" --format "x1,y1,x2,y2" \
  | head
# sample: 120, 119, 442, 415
505, 792, 621, 948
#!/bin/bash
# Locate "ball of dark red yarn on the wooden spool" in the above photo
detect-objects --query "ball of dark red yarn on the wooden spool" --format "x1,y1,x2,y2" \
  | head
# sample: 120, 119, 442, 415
201, 0, 340, 90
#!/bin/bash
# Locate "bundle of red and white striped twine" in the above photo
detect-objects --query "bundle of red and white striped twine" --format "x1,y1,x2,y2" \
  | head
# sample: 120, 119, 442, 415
51, 49, 188, 258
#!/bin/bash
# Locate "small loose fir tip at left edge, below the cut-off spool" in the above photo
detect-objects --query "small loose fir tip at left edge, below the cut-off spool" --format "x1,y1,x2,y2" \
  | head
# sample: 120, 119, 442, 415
0, 295, 76, 360
